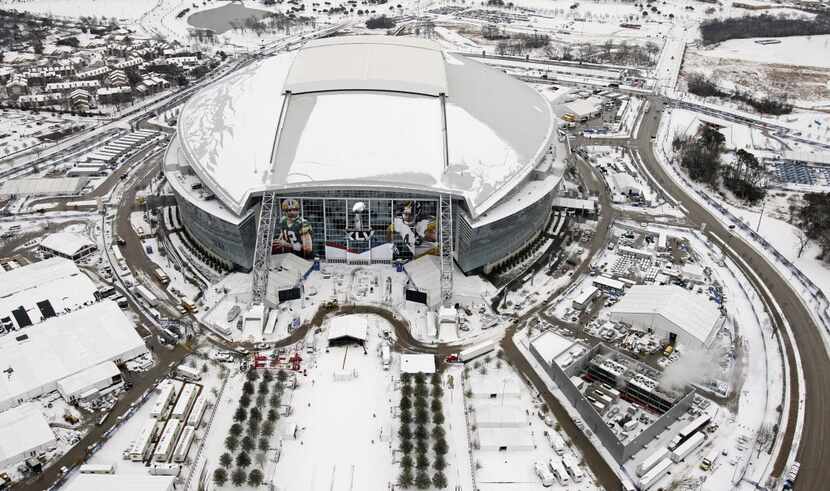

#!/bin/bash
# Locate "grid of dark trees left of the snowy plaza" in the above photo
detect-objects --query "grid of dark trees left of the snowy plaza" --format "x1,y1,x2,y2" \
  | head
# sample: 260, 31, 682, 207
213, 369, 288, 487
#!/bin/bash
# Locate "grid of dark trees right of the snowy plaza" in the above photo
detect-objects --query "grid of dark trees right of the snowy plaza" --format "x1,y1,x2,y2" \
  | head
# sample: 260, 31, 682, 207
398, 373, 449, 489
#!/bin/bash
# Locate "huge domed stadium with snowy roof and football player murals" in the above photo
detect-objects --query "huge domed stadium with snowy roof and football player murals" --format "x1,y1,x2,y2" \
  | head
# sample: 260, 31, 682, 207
164, 36, 563, 273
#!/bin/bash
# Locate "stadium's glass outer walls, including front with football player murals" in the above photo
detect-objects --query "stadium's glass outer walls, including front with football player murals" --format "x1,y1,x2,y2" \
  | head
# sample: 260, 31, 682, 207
172, 186, 553, 273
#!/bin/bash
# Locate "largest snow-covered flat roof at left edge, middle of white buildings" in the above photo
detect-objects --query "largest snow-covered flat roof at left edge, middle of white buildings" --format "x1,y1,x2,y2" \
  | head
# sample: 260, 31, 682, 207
0, 300, 147, 410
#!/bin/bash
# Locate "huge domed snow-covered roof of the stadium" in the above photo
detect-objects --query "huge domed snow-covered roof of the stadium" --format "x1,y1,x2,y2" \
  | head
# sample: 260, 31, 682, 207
178, 36, 554, 216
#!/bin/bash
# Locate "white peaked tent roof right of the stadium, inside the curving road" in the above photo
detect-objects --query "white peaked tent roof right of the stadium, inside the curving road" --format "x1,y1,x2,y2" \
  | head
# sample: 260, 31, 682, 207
611, 285, 722, 345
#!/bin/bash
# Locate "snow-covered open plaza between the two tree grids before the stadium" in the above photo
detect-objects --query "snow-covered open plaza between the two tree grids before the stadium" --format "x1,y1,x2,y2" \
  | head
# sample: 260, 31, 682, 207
273, 316, 397, 491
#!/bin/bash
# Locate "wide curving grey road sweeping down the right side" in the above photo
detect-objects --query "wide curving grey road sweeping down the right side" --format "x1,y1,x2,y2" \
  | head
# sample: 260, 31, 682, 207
576, 98, 830, 490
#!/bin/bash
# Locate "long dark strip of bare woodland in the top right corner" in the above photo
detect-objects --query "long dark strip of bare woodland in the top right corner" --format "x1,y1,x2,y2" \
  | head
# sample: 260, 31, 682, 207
700, 14, 830, 45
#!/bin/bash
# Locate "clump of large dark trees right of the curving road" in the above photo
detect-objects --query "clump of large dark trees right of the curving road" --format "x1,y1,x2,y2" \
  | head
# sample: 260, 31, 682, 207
672, 125, 767, 203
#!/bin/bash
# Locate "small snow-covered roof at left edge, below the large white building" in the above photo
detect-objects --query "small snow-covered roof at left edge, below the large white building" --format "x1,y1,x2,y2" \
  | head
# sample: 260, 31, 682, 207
0, 404, 55, 468
